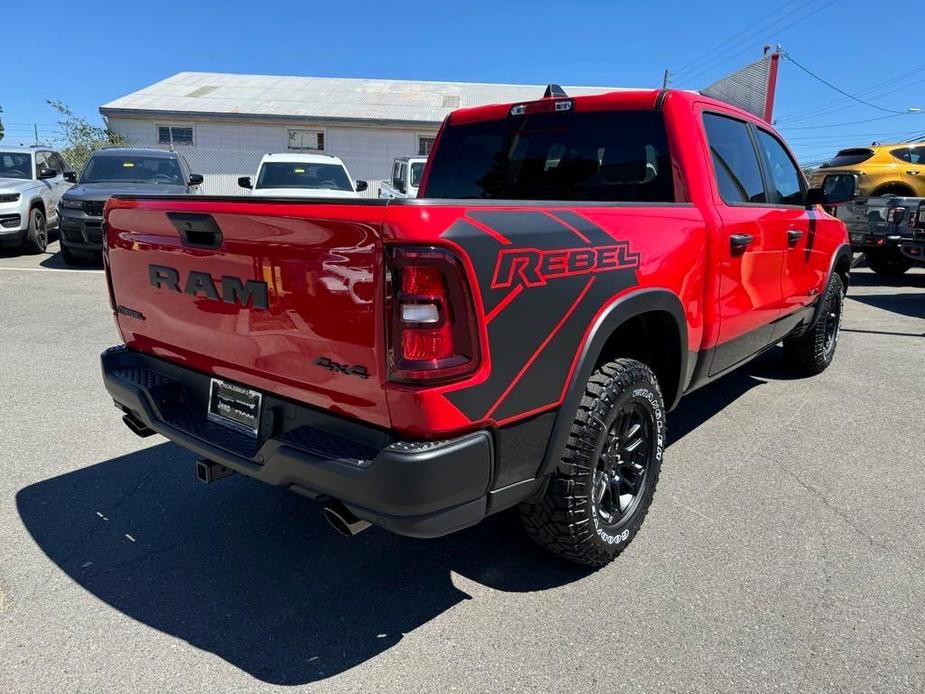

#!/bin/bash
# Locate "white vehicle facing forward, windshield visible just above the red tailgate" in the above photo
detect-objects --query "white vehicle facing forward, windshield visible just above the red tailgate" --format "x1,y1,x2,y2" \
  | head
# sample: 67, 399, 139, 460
238, 153, 368, 198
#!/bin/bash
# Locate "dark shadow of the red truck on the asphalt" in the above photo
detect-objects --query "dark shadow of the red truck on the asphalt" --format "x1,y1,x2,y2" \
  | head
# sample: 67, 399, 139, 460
16, 354, 779, 685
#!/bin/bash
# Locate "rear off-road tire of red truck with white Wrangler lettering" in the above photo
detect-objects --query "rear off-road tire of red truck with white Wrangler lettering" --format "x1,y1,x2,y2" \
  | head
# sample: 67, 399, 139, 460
520, 359, 666, 567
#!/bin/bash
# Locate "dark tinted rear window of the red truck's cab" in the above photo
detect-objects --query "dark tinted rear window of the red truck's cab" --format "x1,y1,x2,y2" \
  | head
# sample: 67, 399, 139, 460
426, 110, 675, 202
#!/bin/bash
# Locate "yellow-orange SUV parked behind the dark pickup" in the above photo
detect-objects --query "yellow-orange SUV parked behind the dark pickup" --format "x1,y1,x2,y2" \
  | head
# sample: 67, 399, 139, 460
812, 143, 925, 197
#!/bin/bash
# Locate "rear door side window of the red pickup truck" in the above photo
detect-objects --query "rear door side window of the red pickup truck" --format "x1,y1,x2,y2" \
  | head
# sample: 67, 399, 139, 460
703, 113, 768, 204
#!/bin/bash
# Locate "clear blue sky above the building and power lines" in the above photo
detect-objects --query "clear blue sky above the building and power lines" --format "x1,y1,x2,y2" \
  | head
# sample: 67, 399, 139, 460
0, 0, 925, 161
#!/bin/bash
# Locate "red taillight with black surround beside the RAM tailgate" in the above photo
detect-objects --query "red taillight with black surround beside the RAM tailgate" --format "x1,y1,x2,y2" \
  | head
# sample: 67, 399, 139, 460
387, 248, 479, 383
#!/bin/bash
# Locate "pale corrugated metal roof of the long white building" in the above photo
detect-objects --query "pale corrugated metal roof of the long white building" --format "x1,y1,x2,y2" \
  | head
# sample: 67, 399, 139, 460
100, 72, 636, 123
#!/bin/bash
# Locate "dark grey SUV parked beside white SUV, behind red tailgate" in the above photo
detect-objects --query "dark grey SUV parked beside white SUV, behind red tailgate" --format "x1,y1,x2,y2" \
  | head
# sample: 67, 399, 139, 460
59, 147, 203, 265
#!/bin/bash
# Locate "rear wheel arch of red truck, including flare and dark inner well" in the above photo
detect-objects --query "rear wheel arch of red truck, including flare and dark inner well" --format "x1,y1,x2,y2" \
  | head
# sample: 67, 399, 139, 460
537, 289, 690, 477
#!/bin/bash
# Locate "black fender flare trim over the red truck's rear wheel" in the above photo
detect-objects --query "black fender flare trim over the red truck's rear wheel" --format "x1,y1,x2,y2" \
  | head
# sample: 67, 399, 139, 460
537, 289, 690, 477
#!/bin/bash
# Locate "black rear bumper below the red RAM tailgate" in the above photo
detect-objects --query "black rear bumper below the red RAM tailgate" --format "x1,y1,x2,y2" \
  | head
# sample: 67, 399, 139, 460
101, 347, 494, 537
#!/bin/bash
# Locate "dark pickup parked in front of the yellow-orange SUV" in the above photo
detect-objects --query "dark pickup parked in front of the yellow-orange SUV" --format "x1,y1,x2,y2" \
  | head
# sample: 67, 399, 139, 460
837, 195, 922, 276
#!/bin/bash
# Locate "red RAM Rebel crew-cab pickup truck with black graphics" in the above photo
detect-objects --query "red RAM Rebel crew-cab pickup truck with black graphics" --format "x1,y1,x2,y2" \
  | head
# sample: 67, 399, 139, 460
102, 89, 853, 566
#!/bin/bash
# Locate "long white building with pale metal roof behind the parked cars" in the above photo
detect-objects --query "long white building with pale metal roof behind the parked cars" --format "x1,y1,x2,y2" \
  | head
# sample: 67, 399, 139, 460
100, 72, 615, 196
